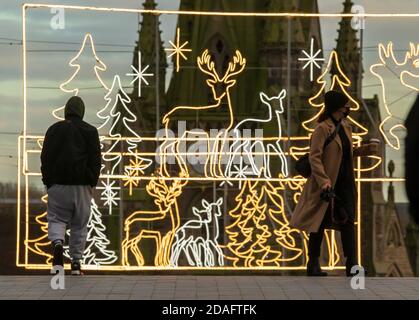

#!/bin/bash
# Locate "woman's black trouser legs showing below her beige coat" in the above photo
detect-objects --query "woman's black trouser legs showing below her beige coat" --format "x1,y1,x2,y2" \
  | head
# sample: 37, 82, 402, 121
308, 223, 356, 261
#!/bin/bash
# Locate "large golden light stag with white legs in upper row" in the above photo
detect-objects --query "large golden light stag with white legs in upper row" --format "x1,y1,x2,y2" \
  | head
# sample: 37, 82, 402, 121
160, 50, 246, 177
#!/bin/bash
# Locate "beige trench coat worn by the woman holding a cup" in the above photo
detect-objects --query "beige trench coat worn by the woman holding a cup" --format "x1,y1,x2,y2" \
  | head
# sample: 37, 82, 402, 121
290, 119, 369, 232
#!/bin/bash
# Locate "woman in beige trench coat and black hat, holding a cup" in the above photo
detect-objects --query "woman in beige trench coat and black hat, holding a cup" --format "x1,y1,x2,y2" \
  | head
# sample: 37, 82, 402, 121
290, 91, 377, 276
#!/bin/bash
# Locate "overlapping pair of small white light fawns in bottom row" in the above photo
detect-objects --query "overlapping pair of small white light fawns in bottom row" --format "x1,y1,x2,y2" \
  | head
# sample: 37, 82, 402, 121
170, 198, 224, 267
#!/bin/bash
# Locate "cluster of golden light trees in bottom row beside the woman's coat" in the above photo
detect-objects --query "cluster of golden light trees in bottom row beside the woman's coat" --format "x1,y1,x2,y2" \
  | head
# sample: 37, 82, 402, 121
226, 181, 305, 267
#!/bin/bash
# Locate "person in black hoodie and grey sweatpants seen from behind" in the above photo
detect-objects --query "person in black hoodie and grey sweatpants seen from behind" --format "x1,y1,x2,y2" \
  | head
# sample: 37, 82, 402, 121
41, 96, 101, 275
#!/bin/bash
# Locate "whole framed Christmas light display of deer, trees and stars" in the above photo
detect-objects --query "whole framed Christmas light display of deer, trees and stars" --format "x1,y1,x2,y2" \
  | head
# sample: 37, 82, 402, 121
16, 5, 398, 271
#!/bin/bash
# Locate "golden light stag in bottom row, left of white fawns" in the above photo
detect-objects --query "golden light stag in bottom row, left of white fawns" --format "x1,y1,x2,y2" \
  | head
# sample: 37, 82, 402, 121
122, 172, 188, 267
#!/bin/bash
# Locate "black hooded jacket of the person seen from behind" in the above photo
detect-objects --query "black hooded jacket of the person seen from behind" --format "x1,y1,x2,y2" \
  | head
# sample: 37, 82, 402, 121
41, 97, 101, 188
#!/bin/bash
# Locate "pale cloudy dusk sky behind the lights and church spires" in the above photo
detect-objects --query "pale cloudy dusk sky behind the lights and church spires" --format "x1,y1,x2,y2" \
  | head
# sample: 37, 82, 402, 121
0, 0, 419, 201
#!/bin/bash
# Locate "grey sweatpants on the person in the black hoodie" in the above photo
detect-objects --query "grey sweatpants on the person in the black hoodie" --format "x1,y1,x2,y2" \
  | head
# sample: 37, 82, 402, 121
47, 184, 92, 260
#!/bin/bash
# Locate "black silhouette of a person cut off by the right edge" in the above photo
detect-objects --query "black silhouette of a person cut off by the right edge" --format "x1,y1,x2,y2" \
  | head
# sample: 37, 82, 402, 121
405, 95, 419, 224
